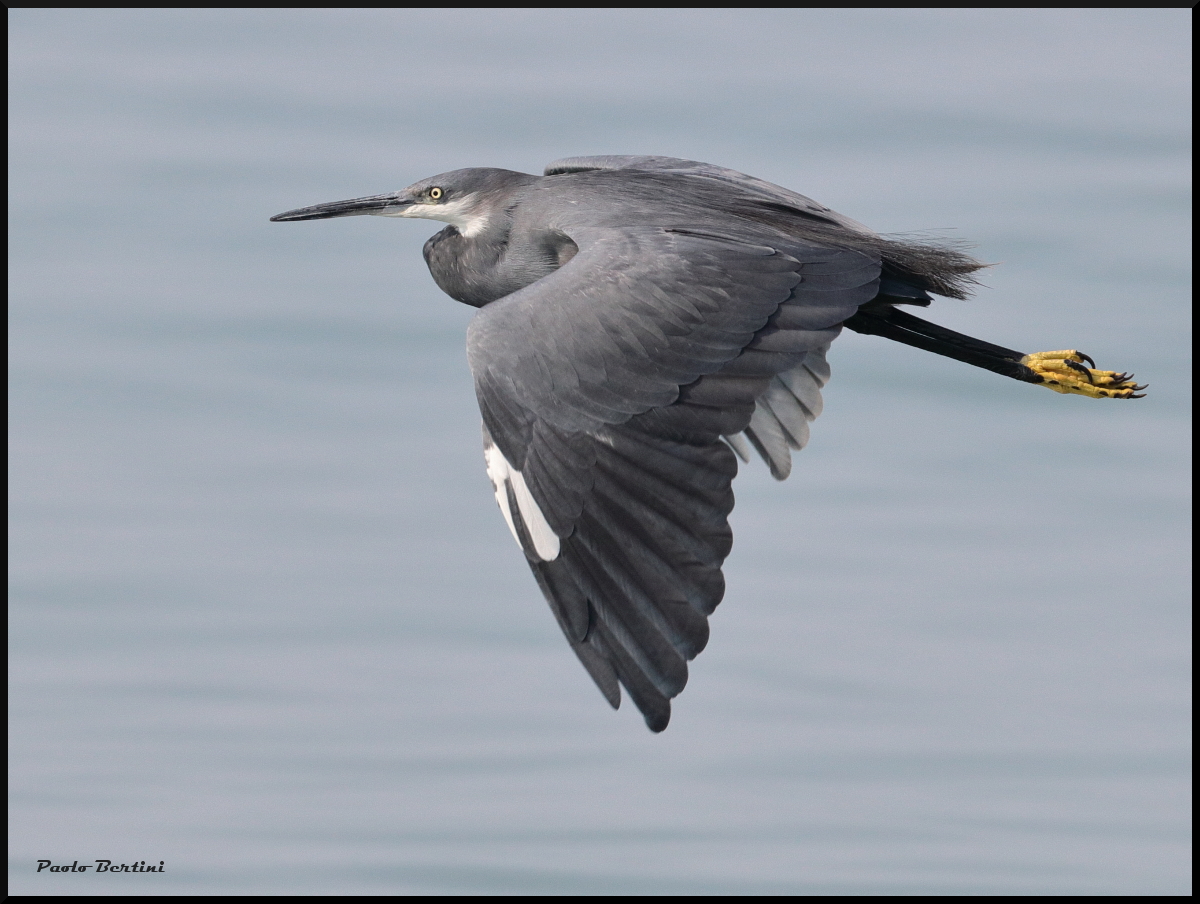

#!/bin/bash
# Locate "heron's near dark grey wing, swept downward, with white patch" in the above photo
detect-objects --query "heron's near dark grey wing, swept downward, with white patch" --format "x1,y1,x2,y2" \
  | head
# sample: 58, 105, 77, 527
468, 222, 880, 731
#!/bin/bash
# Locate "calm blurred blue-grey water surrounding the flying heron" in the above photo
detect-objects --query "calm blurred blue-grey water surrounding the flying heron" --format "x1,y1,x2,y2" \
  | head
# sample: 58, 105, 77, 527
8, 10, 1192, 894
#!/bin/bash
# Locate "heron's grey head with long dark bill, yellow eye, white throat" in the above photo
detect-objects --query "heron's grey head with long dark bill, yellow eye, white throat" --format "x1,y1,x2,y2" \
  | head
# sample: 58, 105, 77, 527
271, 168, 536, 237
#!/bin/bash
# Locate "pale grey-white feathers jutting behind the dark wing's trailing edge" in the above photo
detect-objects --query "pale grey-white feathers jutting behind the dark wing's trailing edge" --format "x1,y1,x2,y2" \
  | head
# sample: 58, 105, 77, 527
725, 348, 829, 480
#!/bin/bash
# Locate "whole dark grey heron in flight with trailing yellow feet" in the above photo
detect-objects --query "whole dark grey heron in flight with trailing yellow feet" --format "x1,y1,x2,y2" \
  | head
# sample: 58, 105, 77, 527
271, 156, 1145, 731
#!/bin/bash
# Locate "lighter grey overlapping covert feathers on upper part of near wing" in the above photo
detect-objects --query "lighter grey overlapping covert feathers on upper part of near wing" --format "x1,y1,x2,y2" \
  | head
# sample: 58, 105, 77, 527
467, 228, 806, 468
